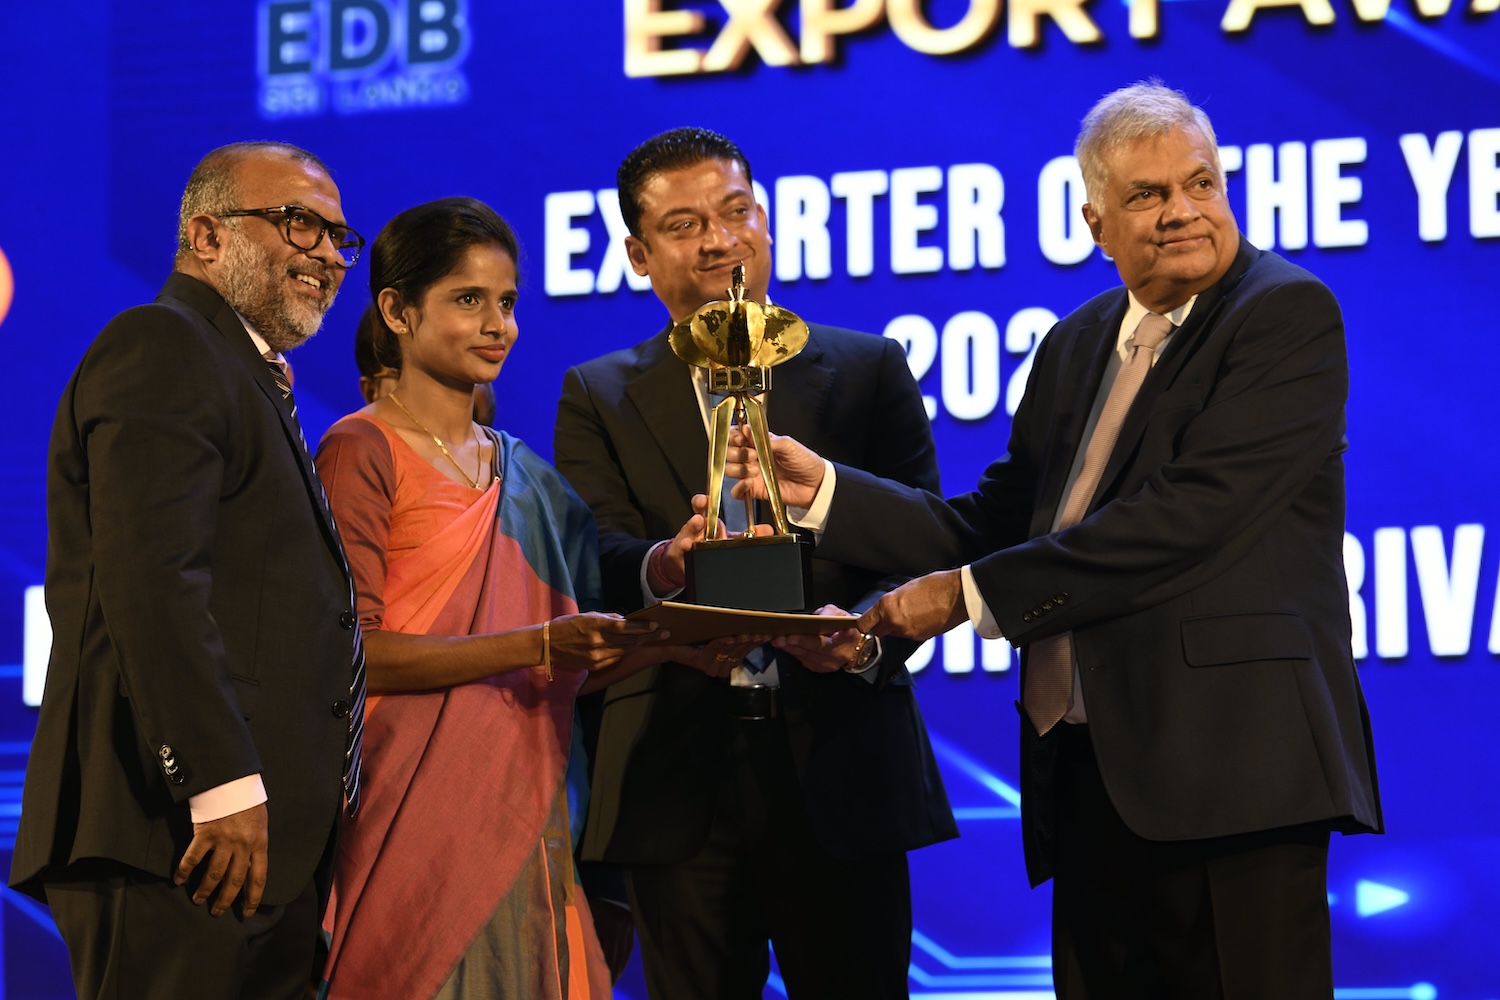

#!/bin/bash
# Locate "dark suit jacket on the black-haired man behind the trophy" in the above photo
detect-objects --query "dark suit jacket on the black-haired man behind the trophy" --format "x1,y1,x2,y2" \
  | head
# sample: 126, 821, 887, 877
555, 325, 959, 864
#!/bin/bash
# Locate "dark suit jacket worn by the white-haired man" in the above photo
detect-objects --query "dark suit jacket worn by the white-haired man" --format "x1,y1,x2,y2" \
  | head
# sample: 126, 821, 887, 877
822, 241, 1382, 880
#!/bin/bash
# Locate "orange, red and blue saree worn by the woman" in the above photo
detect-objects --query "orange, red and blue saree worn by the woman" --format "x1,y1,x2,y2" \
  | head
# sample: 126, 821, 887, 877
317, 414, 609, 1000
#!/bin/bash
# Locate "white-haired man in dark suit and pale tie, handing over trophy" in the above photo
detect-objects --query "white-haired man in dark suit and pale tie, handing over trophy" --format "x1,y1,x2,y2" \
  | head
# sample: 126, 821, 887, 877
732, 82, 1382, 1000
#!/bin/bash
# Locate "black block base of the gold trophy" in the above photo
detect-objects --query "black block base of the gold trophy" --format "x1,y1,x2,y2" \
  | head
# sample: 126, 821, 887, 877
683, 535, 813, 612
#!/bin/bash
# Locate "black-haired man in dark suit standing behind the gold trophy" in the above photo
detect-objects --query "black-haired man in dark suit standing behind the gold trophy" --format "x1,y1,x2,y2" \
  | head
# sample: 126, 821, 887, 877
555, 129, 957, 1000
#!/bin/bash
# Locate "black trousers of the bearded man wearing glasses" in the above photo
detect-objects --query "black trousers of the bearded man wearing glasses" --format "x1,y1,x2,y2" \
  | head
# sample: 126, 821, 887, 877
47, 861, 321, 1000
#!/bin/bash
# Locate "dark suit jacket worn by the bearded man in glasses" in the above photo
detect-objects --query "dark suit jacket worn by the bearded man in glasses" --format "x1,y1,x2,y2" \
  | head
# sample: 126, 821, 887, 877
11, 274, 354, 904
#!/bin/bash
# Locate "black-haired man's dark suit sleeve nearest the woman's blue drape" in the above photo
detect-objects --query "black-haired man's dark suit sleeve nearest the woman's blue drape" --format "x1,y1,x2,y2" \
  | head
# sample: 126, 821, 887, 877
552, 367, 660, 612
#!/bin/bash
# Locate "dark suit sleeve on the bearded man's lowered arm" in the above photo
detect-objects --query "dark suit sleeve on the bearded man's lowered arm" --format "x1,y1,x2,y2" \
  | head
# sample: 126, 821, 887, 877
72, 306, 261, 802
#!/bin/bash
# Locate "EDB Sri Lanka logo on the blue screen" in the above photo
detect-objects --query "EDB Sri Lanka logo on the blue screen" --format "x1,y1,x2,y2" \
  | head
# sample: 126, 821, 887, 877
257, 0, 470, 118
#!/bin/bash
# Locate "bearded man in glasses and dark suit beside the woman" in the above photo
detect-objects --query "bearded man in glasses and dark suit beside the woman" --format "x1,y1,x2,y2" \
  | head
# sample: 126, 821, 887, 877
11, 142, 363, 1000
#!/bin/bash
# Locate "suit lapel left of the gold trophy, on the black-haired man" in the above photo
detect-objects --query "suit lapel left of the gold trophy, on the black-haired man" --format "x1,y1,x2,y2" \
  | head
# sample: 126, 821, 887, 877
626, 330, 708, 496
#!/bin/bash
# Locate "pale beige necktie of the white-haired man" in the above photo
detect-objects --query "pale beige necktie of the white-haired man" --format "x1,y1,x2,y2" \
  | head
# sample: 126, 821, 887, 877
1022, 312, 1172, 736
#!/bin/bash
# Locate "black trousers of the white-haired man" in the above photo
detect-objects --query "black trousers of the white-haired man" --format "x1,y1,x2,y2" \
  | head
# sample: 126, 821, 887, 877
1050, 723, 1334, 1000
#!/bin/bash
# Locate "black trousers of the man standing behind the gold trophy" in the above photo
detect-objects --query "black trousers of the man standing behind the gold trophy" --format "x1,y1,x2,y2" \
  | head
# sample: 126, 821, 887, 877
627, 718, 912, 1000
